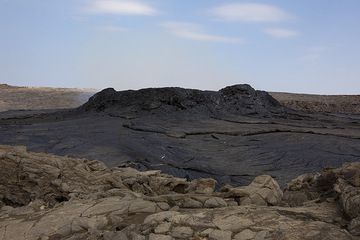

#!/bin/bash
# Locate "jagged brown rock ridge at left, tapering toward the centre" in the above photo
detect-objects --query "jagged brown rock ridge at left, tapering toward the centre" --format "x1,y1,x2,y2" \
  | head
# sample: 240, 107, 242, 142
0, 147, 215, 207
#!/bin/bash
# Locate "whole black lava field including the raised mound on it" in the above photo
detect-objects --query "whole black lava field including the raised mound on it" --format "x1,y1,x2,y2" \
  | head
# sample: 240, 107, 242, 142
0, 85, 360, 188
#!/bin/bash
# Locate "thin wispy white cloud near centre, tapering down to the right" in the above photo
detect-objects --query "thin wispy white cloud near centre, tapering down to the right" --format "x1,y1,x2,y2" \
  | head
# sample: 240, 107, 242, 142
162, 22, 243, 43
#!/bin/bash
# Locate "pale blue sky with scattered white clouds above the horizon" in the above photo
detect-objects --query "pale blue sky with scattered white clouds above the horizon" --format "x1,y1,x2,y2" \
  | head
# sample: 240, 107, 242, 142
0, 0, 360, 94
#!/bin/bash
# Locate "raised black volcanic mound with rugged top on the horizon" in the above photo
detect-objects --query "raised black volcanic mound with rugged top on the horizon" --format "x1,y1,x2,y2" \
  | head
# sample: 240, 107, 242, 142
79, 84, 283, 116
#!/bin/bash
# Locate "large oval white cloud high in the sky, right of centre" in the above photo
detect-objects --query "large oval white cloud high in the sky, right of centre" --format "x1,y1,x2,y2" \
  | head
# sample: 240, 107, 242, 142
210, 3, 291, 22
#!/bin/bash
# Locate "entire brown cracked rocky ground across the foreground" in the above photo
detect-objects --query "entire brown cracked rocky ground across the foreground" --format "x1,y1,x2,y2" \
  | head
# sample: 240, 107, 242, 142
0, 146, 360, 240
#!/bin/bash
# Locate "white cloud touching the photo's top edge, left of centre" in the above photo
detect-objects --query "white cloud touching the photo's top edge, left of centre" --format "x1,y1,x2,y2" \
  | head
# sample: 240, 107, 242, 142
86, 0, 158, 16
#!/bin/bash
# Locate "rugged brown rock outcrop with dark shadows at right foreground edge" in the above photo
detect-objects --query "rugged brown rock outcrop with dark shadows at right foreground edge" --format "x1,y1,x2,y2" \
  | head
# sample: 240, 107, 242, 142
283, 162, 360, 236
